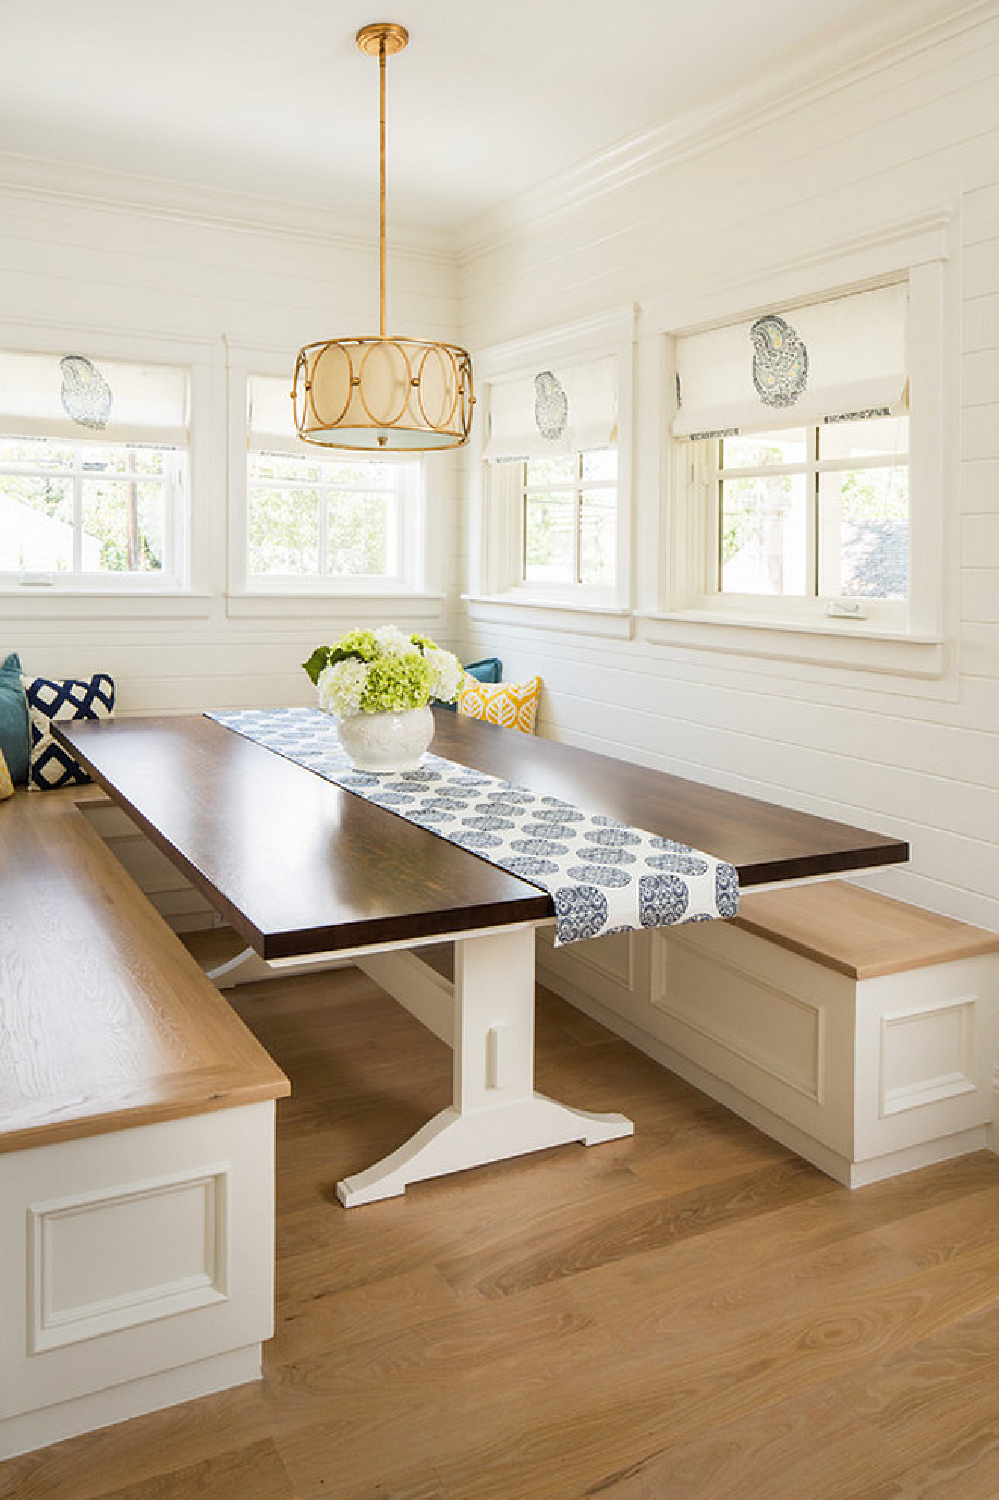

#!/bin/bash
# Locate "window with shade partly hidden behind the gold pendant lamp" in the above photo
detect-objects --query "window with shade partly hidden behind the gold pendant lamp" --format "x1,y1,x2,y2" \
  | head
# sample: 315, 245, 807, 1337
246, 377, 423, 591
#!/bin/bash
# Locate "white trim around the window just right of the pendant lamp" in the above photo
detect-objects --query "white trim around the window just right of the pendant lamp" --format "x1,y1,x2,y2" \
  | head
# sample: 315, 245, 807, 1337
462, 305, 636, 636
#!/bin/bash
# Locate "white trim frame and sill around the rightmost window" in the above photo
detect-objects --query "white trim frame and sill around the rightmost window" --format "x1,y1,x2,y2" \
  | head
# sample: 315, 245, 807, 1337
636, 210, 960, 678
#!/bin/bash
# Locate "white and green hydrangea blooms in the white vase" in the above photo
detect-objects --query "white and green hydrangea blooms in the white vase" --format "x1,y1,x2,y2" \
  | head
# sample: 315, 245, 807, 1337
303, 626, 465, 719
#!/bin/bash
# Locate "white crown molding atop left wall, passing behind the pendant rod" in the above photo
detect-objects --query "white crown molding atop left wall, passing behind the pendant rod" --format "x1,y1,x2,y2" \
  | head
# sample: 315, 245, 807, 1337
0, 152, 455, 266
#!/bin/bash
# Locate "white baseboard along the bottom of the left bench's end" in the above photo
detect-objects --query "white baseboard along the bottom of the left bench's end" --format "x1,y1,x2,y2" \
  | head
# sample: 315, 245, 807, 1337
0, 1344, 261, 1463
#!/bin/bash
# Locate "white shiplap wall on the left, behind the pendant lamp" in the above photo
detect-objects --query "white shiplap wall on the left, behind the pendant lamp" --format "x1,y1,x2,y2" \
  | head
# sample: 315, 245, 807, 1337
0, 167, 461, 713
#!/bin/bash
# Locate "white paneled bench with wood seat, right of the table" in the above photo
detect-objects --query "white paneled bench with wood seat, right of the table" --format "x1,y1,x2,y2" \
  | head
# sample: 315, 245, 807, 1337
540, 881, 999, 1187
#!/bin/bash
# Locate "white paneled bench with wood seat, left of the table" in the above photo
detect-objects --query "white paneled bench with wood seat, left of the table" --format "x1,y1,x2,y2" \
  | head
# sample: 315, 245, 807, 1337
0, 788, 290, 1460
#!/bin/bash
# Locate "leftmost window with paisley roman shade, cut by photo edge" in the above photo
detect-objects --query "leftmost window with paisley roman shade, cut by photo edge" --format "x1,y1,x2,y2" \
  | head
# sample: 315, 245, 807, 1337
0, 353, 189, 588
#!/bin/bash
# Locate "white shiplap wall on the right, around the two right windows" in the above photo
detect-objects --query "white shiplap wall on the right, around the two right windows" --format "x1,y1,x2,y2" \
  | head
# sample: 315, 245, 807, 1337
462, 6, 999, 929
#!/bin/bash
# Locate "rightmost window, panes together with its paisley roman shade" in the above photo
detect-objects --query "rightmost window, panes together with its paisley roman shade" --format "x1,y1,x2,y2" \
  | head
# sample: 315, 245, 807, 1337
674, 282, 912, 630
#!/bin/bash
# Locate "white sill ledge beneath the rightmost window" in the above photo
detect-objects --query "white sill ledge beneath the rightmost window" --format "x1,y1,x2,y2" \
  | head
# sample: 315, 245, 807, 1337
636, 609, 947, 678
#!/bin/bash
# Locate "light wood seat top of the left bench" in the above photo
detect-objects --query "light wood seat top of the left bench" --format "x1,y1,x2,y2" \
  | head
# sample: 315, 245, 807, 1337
0, 788, 290, 1152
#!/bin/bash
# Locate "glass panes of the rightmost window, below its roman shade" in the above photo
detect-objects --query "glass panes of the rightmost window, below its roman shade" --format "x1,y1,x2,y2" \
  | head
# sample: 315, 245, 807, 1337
710, 416, 909, 602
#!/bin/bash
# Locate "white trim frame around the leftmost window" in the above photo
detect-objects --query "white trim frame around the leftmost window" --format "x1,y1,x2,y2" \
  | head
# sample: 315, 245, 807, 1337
0, 321, 225, 620
